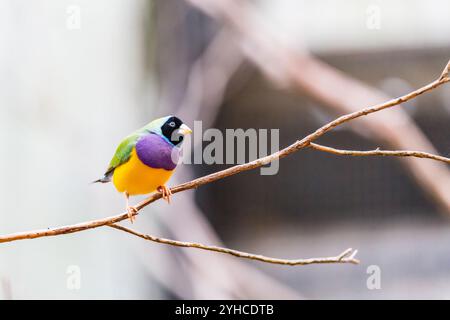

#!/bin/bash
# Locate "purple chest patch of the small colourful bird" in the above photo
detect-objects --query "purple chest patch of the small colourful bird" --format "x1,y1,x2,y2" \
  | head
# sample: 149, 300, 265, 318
136, 134, 179, 170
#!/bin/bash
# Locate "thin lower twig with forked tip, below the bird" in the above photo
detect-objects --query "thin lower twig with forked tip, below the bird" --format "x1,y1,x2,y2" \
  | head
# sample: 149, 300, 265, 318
108, 224, 359, 266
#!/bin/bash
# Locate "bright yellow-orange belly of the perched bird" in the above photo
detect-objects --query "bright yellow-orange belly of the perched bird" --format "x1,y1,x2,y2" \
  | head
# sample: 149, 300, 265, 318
113, 149, 173, 195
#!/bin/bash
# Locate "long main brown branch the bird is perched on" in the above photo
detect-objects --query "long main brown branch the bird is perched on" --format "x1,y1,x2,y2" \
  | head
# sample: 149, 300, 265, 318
0, 67, 450, 243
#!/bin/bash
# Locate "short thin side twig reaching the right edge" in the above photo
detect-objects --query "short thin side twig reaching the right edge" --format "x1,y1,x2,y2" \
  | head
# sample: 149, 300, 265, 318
309, 143, 450, 164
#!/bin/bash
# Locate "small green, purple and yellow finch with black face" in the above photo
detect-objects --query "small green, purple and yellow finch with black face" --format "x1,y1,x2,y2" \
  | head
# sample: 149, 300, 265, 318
94, 116, 192, 222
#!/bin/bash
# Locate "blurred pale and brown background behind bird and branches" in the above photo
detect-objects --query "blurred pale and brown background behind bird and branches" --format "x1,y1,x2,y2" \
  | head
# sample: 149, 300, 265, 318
0, 0, 450, 299
